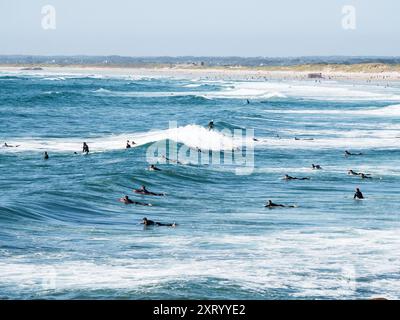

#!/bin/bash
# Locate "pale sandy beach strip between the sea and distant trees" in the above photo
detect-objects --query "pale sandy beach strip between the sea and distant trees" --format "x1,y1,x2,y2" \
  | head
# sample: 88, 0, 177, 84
0, 65, 400, 82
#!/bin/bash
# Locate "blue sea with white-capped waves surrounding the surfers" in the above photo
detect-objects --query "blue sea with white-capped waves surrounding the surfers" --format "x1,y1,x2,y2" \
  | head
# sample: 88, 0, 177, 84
0, 71, 400, 299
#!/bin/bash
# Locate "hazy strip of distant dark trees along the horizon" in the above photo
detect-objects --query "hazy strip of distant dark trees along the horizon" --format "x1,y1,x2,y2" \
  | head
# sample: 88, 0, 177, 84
0, 55, 400, 67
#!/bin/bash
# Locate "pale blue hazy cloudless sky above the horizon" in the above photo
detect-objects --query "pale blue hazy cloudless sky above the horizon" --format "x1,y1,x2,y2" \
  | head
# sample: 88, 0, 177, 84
0, 0, 400, 56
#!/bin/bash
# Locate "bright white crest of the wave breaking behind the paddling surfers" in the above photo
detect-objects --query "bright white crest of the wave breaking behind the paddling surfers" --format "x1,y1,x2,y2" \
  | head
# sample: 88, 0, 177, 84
0, 125, 240, 152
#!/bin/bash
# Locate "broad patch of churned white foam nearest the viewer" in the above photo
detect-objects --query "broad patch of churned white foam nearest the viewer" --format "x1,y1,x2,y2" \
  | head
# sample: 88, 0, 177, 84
0, 228, 400, 299
